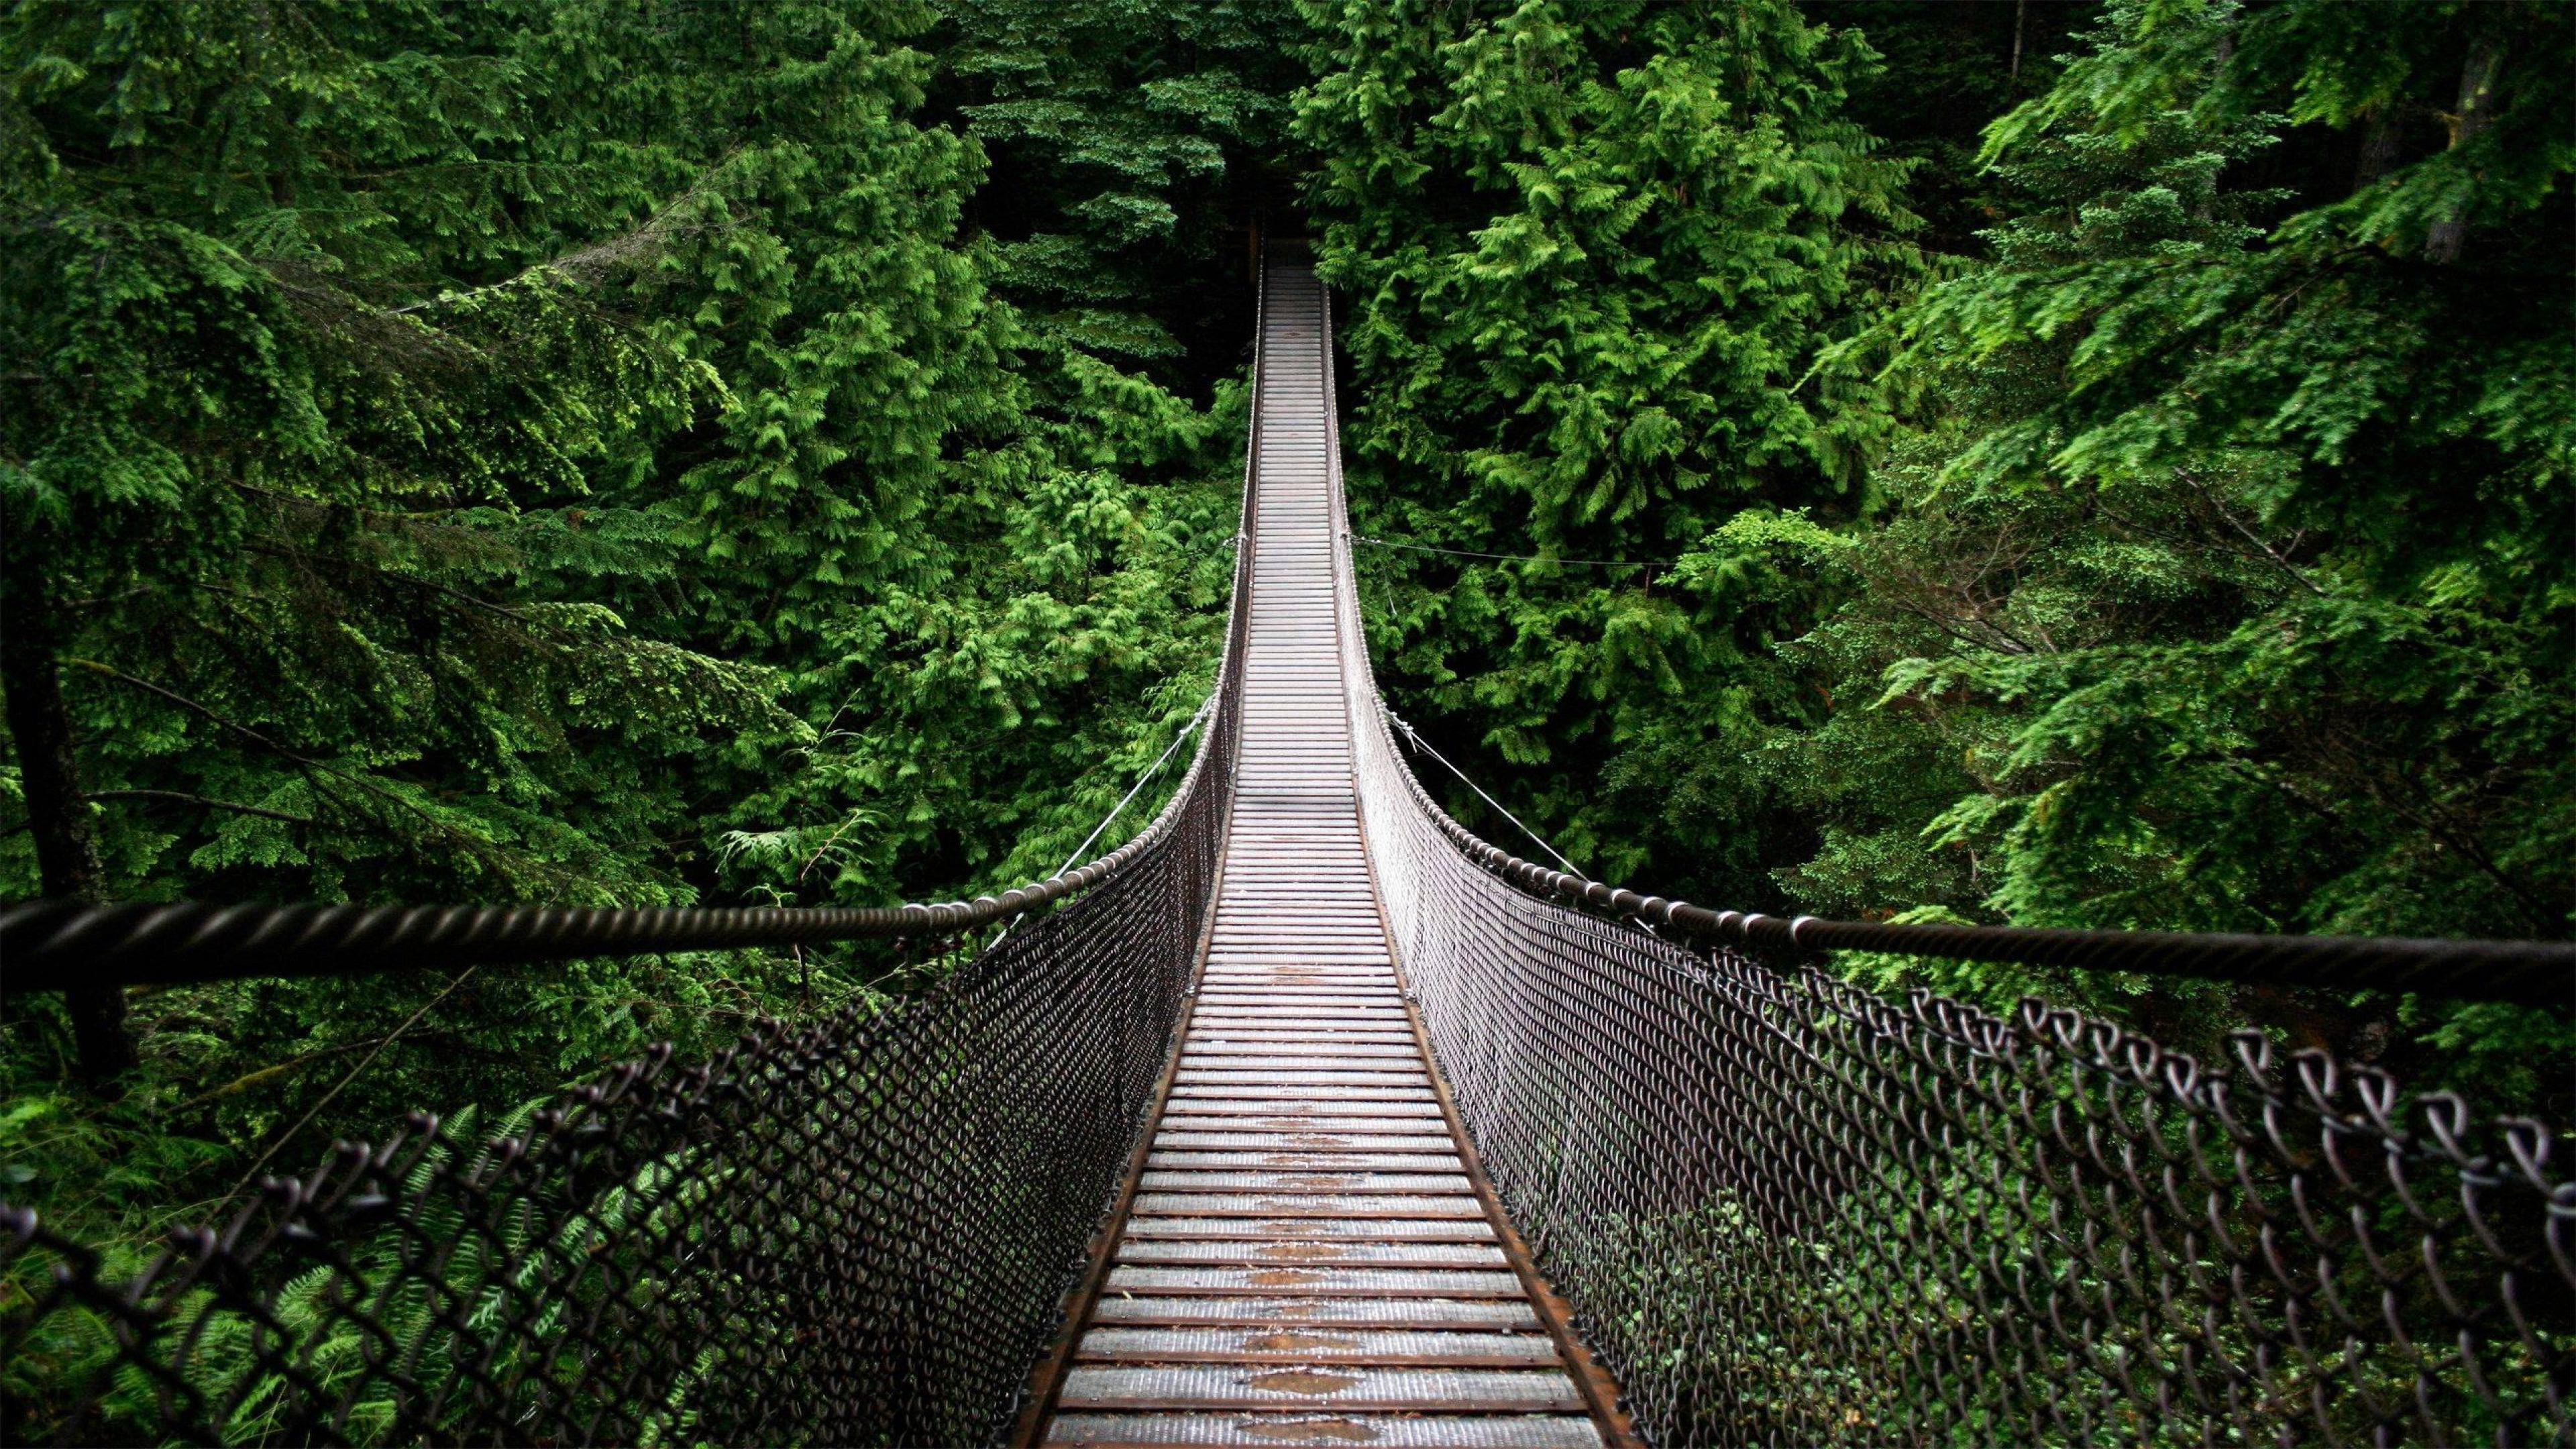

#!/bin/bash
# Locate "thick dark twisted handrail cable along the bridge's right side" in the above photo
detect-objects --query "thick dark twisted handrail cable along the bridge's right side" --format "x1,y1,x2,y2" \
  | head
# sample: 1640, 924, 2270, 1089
1381, 701, 2576, 1008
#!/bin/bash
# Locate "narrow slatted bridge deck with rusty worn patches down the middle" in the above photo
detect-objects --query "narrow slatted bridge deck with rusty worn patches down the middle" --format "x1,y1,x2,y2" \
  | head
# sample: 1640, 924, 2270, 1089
1046, 263, 1602, 1449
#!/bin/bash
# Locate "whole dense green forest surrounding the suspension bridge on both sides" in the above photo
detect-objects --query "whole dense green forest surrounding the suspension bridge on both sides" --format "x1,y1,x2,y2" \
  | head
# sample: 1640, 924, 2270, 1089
0, 0, 2576, 1240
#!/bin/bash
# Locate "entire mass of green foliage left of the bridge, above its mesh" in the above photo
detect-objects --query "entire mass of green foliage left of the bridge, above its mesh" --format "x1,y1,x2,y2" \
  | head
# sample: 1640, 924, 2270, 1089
0, 0, 1242, 1252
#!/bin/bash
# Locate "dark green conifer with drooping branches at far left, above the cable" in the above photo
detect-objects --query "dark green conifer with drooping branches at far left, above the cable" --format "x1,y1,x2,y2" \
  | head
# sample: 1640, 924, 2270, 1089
0, 5, 783, 1083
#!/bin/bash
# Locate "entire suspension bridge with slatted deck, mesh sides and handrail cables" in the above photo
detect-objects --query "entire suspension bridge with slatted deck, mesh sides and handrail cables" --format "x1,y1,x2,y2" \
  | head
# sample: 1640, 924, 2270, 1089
0, 253, 2576, 1449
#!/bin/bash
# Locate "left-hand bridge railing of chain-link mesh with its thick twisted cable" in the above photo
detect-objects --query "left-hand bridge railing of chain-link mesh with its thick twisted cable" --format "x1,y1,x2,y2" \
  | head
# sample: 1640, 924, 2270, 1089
0, 296, 1252, 1446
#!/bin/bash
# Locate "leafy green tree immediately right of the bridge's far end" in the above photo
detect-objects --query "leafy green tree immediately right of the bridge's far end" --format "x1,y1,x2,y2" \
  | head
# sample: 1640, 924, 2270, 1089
1298, 0, 1909, 895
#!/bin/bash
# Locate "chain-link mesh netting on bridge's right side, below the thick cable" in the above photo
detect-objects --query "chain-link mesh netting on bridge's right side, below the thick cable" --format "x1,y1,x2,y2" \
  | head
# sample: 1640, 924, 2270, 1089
1360, 675, 2576, 1446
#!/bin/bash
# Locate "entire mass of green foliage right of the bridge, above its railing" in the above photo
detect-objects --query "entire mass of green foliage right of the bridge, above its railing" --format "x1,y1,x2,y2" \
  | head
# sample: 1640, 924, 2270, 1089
1298, 0, 2576, 1083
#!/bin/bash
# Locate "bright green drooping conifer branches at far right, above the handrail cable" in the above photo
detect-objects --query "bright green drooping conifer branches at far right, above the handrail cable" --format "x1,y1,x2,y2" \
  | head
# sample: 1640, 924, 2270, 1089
1695, 3, 2576, 1083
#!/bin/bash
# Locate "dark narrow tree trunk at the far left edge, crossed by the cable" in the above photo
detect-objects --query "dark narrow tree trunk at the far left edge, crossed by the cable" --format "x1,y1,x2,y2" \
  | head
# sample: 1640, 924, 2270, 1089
0, 551, 137, 1095
